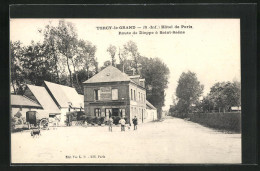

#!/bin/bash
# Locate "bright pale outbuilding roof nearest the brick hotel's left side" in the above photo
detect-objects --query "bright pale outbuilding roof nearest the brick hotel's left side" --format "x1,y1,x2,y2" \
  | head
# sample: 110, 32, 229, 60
44, 81, 84, 108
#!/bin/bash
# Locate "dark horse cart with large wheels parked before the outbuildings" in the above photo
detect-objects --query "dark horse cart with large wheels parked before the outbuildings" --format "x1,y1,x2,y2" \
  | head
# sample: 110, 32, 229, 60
26, 111, 49, 129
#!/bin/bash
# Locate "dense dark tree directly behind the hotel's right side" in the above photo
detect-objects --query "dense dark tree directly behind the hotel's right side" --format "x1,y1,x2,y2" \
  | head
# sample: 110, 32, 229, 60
140, 57, 170, 119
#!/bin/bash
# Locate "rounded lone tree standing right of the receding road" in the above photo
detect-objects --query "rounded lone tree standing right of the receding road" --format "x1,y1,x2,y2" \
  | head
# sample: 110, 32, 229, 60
176, 71, 204, 116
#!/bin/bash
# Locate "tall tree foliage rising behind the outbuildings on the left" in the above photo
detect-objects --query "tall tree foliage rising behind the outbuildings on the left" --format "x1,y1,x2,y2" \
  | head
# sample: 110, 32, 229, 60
10, 20, 98, 93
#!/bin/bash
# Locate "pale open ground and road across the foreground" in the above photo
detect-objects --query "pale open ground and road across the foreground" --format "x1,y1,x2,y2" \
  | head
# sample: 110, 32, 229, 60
11, 117, 241, 164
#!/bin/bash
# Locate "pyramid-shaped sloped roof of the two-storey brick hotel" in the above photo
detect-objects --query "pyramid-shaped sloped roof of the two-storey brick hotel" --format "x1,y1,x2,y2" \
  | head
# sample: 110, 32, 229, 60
83, 65, 131, 83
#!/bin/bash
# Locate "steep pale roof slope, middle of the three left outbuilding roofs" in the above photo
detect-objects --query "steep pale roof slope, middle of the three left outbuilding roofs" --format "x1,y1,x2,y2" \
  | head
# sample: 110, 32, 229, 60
27, 84, 60, 113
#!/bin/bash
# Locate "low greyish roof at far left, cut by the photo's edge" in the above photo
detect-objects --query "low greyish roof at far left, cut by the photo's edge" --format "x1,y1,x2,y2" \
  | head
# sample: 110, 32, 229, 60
11, 94, 42, 108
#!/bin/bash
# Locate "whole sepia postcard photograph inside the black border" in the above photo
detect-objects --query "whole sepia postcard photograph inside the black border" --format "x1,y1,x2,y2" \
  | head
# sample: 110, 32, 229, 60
9, 18, 242, 164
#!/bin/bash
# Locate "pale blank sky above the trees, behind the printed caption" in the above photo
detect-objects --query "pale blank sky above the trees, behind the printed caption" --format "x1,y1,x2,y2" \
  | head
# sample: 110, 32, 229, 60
10, 19, 241, 110
